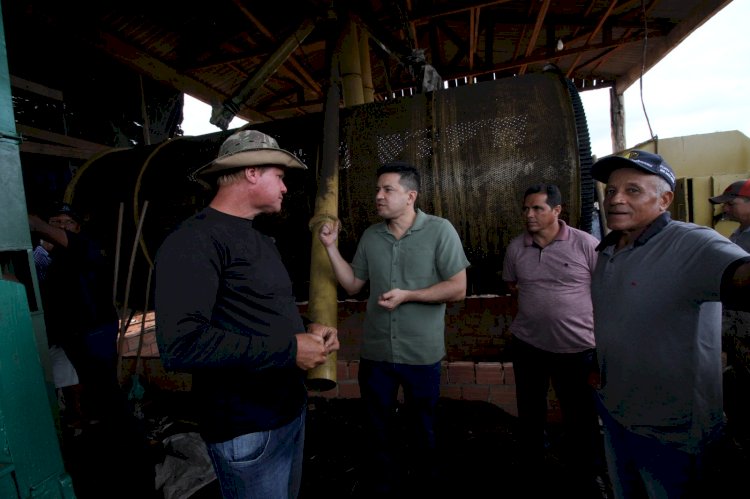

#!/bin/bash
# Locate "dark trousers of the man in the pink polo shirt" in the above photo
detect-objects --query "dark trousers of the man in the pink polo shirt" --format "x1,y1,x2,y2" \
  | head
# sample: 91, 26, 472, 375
511, 336, 604, 480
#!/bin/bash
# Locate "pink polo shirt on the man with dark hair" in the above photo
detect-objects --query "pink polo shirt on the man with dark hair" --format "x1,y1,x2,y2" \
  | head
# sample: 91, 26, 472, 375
503, 220, 599, 353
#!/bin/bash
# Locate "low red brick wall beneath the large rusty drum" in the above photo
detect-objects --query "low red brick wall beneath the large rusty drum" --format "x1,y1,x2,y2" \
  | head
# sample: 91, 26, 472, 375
123, 296, 536, 415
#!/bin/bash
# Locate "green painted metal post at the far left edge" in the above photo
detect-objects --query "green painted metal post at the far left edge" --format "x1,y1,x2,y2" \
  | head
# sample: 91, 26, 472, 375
0, 1, 75, 499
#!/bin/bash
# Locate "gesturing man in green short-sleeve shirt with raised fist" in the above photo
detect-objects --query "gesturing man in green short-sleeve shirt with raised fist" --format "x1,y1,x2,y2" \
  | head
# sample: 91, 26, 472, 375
319, 162, 469, 495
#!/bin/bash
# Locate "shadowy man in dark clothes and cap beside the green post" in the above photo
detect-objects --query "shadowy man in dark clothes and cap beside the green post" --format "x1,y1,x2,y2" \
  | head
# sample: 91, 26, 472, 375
28, 203, 154, 497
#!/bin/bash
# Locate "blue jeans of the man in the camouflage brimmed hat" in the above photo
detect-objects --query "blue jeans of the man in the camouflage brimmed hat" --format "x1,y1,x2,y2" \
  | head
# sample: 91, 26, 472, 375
206, 409, 306, 499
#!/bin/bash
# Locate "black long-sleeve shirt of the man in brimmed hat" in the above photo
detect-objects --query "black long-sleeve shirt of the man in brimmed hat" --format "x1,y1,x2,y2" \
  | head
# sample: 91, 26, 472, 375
154, 208, 307, 442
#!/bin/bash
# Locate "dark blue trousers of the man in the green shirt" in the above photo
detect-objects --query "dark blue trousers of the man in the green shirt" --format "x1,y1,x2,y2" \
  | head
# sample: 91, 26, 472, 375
358, 359, 440, 494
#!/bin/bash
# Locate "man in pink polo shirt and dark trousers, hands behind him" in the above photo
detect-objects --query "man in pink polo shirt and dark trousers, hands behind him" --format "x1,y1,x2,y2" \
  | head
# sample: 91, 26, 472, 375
503, 184, 603, 497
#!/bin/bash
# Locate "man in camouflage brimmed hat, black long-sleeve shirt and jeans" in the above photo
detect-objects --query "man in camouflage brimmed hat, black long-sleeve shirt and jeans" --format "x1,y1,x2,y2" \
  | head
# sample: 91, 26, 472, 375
155, 130, 339, 499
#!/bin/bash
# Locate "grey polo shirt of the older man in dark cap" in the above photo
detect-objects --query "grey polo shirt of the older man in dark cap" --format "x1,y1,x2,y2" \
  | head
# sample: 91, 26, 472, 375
592, 216, 748, 452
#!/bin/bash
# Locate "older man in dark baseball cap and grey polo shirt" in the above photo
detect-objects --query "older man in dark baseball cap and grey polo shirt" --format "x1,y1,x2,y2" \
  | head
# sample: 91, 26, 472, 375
591, 150, 750, 498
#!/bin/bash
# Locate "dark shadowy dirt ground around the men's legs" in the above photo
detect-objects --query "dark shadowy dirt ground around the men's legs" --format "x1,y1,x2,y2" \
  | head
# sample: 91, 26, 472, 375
63, 393, 750, 499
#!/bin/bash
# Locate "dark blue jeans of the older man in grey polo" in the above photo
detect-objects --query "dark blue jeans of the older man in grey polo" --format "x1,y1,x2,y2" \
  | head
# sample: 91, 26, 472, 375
599, 398, 701, 499
